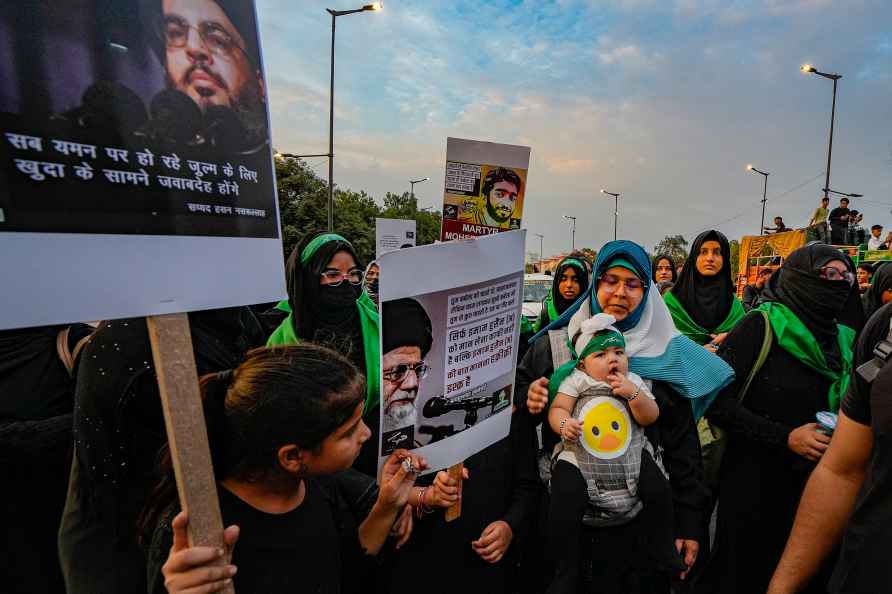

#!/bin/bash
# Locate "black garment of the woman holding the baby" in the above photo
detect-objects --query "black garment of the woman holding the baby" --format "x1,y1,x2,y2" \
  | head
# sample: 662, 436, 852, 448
514, 334, 712, 594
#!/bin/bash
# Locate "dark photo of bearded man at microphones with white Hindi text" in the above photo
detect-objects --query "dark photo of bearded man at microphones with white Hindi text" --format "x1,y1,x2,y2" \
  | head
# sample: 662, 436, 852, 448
0, 0, 278, 238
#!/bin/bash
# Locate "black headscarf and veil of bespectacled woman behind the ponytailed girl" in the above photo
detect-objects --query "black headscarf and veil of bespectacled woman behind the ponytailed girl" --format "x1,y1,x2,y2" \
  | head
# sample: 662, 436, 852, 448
285, 231, 365, 369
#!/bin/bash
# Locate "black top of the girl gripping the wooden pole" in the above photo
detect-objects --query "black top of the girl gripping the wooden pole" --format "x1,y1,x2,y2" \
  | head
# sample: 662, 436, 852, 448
146, 477, 377, 594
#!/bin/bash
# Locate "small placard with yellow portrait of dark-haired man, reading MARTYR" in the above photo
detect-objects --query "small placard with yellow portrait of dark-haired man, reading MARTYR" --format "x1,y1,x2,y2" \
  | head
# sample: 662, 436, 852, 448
440, 138, 530, 241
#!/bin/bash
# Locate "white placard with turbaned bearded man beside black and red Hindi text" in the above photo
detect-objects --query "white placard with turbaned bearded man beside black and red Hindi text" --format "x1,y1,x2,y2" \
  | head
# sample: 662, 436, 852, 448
379, 231, 526, 470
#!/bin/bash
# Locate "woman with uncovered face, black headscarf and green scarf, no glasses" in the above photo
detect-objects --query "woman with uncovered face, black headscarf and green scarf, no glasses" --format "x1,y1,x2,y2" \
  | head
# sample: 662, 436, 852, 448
663, 231, 746, 352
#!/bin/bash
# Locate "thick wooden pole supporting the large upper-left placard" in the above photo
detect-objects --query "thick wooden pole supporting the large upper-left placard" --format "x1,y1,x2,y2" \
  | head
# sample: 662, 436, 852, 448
146, 313, 235, 594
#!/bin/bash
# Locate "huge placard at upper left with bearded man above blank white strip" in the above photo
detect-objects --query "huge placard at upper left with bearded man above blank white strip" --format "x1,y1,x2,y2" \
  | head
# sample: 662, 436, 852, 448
0, 0, 284, 328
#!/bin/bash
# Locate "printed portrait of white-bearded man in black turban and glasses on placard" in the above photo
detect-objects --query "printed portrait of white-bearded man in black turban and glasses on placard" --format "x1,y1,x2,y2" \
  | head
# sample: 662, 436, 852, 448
381, 299, 433, 453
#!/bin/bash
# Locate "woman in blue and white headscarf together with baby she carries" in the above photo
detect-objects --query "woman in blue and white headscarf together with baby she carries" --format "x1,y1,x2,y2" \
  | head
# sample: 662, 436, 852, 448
516, 241, 733, 593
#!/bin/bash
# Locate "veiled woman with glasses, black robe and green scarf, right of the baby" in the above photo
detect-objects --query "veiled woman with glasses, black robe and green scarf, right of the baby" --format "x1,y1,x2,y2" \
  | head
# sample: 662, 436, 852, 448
700, 244, 855, 594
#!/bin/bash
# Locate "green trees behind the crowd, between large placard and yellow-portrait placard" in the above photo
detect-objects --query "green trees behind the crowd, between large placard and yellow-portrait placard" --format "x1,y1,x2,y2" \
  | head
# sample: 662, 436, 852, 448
276, 159, 440, 263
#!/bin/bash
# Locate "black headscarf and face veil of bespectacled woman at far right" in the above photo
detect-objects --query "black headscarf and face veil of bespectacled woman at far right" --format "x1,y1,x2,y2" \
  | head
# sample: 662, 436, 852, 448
761, 242, 857, 369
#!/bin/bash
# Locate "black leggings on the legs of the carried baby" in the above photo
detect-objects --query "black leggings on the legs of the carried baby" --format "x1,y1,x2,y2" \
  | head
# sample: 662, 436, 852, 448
548, 451, 686, 594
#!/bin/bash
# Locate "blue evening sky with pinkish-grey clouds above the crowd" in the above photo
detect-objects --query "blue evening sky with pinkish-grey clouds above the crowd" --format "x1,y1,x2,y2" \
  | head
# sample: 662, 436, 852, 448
257, 0, 892, 255
